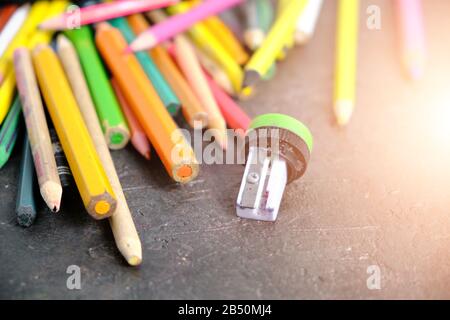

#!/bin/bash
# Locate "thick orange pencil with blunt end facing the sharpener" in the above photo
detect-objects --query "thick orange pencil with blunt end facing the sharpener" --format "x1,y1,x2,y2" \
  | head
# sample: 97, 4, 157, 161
95, 22, 199, 183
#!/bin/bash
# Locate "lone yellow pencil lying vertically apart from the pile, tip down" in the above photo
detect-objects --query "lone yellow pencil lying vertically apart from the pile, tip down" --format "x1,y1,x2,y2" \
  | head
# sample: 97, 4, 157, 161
333, 0, 359, 126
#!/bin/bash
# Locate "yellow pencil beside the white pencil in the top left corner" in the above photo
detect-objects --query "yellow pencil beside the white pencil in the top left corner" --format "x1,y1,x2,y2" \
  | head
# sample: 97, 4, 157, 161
0, 1, 50, 83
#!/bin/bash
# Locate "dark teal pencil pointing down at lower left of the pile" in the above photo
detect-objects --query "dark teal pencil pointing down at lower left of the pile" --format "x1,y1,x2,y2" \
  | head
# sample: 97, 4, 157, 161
16, 134, 36, 227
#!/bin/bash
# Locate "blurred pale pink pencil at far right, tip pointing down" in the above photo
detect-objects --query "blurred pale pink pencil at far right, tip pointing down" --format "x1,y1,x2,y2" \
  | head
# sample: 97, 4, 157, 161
396, 0, 426, 80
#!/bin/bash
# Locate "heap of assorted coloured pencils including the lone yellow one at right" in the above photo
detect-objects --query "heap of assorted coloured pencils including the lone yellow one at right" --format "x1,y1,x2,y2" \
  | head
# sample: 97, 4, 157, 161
0, 0, 422, 265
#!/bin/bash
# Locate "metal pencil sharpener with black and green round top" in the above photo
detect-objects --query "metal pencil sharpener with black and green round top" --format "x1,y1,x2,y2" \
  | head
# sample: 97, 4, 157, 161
236, 114, 313, 221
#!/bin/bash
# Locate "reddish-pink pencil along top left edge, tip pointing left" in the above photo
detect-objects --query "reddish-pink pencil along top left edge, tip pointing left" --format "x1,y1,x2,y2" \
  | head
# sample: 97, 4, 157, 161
39, 0, 178, 30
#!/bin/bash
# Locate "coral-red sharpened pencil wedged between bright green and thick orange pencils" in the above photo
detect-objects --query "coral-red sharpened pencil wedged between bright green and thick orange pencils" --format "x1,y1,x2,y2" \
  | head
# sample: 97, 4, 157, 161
111, 79, 150, 160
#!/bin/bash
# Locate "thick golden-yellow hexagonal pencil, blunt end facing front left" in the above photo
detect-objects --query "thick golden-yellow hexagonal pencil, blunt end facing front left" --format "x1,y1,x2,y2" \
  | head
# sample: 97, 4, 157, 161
33, 45, 116, 219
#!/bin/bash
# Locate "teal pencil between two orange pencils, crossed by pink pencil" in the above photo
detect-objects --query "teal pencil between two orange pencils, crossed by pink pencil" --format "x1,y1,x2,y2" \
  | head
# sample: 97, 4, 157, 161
109, 18, 181, 115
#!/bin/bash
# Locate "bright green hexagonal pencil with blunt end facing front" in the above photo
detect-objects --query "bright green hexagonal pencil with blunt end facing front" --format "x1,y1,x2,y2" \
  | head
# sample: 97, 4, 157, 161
65, 26, 130, 150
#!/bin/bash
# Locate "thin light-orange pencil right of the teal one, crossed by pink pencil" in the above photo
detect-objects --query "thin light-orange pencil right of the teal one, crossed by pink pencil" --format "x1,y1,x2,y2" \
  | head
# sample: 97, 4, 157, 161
128, 14, 208, 129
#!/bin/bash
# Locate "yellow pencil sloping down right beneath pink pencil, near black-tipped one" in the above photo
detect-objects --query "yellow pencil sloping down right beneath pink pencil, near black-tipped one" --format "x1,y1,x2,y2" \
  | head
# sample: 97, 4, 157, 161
162, 2, 247, 95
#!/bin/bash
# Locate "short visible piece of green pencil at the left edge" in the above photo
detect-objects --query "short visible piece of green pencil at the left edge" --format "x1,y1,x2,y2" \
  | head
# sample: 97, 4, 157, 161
0, 96, 22, 169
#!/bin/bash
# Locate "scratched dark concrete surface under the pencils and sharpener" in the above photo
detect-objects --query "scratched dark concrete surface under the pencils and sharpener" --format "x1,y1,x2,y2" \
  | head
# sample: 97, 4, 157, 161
0, 0, 450, 299
